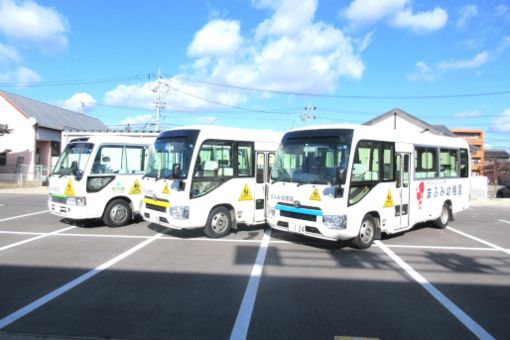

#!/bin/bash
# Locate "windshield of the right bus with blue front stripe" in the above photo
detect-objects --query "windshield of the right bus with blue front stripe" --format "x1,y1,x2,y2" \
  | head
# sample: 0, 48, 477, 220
271, 129, 353, 185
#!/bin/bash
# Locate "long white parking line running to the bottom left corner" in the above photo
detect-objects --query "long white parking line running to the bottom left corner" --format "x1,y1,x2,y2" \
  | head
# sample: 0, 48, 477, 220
0, 234, 162, 330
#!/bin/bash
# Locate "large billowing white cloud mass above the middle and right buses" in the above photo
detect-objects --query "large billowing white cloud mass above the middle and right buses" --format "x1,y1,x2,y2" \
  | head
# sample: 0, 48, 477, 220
105, 0, 364, 115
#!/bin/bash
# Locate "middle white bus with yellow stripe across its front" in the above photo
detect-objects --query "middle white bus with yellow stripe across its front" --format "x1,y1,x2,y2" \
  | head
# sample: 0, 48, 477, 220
141, 126, 283, 238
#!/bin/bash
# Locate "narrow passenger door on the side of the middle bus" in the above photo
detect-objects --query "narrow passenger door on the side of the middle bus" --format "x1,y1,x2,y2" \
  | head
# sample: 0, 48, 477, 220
255, 152, 275, 223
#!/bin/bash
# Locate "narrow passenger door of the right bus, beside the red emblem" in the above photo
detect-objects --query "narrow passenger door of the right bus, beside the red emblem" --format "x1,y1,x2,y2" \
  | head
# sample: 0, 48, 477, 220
395, 153, 411, 228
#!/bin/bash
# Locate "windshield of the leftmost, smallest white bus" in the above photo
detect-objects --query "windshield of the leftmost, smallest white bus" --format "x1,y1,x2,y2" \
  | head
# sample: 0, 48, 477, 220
53, 143, 94, 176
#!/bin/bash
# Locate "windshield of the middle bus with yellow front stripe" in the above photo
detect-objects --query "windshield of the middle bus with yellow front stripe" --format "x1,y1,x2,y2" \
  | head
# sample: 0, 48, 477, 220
145, 130, 198, 179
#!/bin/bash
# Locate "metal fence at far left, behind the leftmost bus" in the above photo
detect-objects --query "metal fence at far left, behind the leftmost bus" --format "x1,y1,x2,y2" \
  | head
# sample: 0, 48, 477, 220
0, 164, 48, 188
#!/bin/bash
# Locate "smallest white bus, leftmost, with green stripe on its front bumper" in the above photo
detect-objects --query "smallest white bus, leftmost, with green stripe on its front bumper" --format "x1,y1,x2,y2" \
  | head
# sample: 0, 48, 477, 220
48, 136, 155, 227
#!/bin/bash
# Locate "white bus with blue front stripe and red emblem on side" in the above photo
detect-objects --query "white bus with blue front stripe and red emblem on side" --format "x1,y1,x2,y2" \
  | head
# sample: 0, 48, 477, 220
268, 124, 470, 249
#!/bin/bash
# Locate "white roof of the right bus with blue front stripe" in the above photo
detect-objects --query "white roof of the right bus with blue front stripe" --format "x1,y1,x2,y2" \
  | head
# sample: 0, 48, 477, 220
287, 124, 468, 148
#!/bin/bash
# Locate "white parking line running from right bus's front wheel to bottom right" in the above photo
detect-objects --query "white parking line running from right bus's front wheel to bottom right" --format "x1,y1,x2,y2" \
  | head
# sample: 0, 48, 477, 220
375, 241, 494, 339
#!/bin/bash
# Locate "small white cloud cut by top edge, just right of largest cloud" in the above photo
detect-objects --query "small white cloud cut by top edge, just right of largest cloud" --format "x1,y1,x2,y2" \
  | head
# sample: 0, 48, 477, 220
344, 0, 409, 25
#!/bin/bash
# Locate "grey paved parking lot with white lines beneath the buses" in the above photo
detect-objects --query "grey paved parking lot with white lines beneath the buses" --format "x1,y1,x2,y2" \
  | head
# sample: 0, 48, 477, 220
0, 193, 510, 339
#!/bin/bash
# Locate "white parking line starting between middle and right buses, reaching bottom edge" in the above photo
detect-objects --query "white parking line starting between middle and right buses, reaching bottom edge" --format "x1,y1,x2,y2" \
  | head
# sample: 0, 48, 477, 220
230, 229, 271, 340
